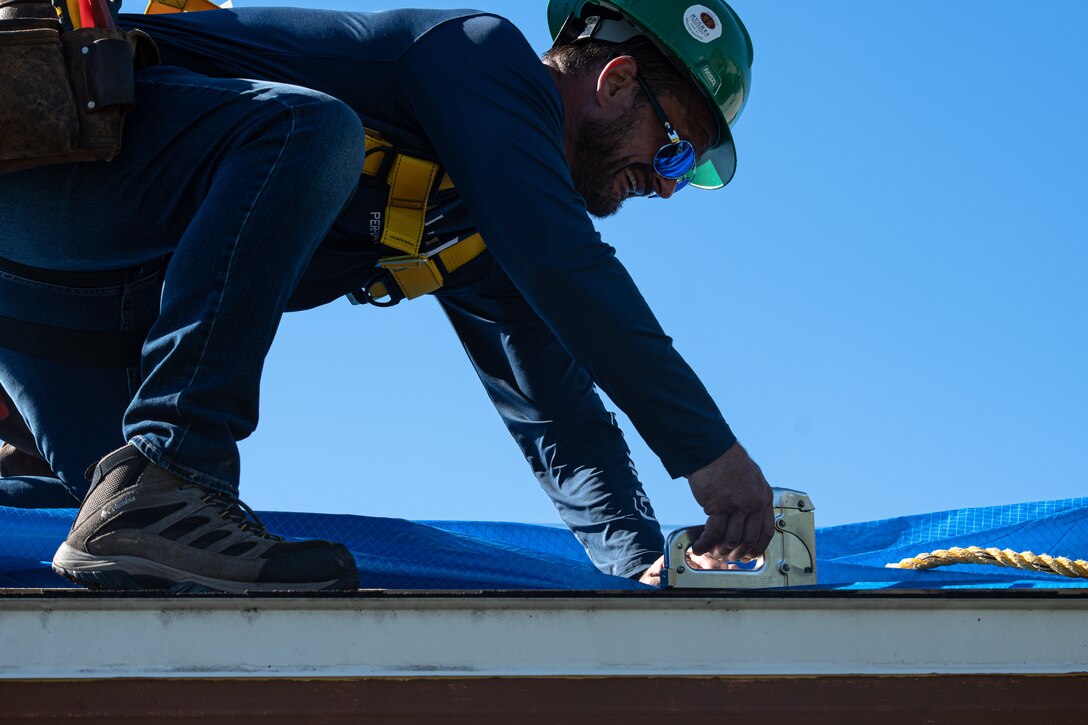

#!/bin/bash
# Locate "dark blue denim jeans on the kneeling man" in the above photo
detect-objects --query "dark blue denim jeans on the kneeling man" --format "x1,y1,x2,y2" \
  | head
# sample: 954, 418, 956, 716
0, 66, 363, 505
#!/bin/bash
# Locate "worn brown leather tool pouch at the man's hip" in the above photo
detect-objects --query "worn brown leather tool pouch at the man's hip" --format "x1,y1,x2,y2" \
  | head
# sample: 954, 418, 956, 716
0, 0, 159, 173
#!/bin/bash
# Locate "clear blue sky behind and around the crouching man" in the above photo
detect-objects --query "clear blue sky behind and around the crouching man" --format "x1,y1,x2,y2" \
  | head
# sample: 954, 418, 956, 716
216, 0, 1088, 526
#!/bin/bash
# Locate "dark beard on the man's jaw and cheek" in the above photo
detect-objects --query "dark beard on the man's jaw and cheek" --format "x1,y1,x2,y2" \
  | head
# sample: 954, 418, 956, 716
570, 102, 641, 219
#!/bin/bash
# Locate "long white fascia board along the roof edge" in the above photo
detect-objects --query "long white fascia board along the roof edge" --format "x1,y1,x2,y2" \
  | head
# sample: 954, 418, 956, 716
0, 595, 1088, 678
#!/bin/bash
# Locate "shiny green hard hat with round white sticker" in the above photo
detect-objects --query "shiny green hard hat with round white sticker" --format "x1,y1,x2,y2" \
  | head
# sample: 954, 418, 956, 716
547, 0, 752, 188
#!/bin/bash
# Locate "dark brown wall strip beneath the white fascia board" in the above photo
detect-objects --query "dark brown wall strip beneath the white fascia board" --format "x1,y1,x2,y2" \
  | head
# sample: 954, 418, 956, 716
0, 674, 1088, 725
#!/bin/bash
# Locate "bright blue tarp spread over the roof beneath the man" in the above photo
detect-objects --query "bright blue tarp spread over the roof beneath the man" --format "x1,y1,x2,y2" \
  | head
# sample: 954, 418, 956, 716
0, 499, 1088, 590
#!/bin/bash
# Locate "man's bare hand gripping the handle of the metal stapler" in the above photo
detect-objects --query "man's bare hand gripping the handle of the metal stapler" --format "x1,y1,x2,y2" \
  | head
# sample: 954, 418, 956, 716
687, 443, 775, 557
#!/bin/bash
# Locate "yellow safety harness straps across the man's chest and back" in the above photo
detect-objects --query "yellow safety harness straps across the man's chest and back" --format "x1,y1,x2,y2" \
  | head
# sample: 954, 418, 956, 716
145, 0, 486, 307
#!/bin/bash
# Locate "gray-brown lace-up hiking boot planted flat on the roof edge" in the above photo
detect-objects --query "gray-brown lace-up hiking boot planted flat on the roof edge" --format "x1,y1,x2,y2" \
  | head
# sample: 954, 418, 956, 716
53, 444, 359, 591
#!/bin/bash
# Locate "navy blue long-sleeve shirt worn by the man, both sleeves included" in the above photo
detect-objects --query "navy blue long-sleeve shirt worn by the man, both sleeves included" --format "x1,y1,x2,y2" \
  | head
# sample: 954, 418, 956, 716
129, 9, 735, 576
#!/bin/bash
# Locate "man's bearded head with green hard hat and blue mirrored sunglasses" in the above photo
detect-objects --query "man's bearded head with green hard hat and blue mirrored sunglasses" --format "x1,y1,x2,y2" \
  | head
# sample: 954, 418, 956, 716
544, 0, 752, 216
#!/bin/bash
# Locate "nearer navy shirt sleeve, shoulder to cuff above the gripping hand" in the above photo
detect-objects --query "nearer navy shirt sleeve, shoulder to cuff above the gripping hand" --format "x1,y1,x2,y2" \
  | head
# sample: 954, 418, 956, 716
396, 15, 735, 477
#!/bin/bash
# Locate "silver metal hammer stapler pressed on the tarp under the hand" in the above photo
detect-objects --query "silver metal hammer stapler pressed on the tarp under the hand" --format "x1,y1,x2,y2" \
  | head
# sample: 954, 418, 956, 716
662, 489, 816, 589
